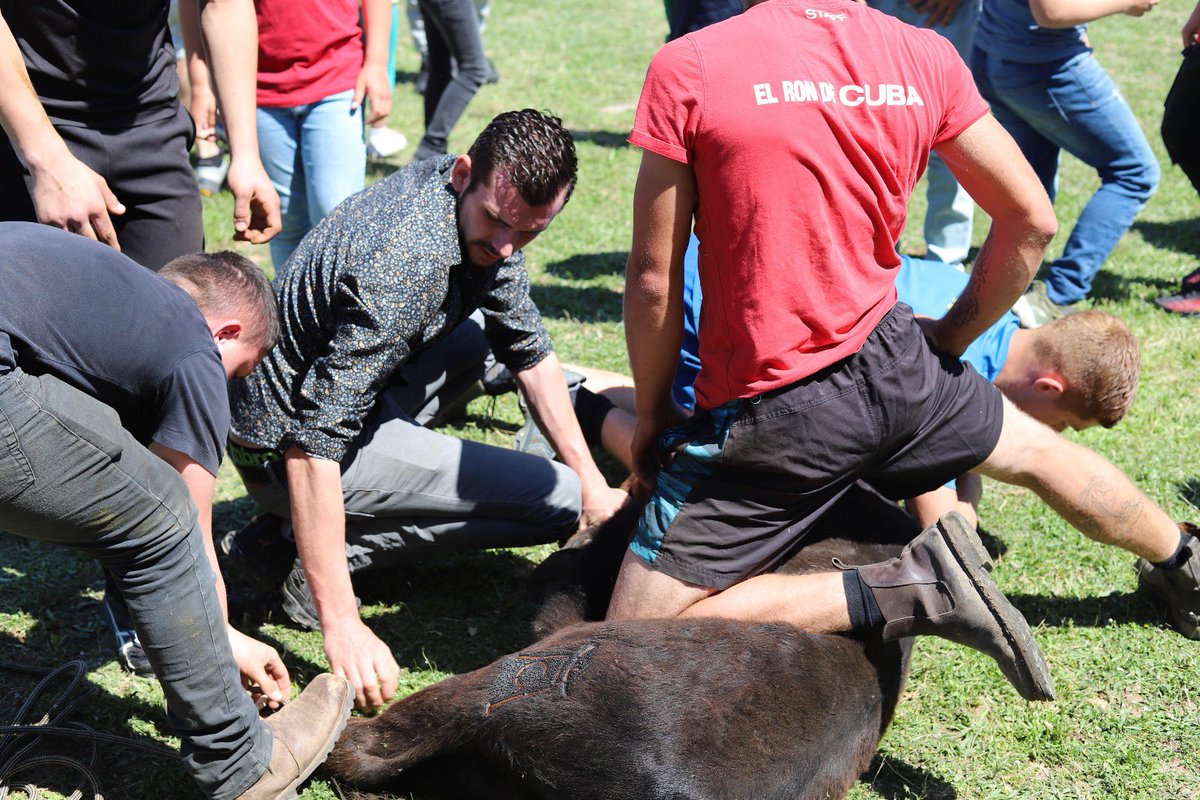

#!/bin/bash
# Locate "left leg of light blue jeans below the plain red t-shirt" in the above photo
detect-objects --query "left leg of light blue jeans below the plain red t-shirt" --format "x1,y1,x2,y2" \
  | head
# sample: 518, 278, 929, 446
257, 107, 308, 272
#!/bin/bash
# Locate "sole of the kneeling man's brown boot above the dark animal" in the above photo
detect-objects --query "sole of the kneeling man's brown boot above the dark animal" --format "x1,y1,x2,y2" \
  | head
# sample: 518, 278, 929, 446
937, 515, 1055, 700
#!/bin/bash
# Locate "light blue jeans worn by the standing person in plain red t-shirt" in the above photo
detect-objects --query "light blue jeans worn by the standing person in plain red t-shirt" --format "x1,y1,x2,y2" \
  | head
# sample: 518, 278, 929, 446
258, 90, 367, 271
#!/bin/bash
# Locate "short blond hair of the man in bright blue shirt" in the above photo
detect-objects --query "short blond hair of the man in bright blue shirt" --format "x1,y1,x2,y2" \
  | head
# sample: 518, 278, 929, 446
1032, 311, 1141, 428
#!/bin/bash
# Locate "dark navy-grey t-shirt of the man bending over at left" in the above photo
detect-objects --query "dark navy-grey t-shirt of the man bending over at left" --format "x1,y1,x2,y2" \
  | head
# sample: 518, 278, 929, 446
0, 222, 229, 475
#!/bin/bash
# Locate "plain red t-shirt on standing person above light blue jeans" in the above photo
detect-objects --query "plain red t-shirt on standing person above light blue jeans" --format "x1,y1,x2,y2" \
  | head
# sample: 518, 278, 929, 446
254, 0, 362, 108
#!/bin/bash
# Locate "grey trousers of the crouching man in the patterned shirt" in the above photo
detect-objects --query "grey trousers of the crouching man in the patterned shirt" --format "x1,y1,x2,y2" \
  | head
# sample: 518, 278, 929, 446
246, 318, 581, 572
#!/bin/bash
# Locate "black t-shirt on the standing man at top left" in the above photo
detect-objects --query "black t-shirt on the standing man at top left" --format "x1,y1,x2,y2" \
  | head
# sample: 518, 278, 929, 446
0, 0, 179, 130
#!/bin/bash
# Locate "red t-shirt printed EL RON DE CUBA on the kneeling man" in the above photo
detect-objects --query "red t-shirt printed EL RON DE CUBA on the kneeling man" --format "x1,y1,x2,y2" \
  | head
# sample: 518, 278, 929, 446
629, 0, 988, 408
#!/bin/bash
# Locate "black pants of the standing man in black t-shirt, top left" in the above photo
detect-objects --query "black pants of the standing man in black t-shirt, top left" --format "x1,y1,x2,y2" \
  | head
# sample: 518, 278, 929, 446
0, 108, 204, 270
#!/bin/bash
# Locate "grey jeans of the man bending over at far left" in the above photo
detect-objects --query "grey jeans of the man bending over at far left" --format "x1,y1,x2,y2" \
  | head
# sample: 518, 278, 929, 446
0, 362, 272, 798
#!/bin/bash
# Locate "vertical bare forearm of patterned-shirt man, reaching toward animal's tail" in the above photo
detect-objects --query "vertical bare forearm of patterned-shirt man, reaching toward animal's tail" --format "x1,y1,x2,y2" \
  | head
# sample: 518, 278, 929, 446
284, 446, 359, 628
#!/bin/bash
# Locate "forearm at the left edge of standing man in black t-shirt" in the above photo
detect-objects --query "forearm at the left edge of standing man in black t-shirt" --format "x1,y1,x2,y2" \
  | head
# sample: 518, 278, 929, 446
0, 17, 67, 173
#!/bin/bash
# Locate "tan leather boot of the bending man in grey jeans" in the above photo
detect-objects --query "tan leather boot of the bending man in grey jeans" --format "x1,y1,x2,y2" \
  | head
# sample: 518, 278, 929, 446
239, 673, 354, 800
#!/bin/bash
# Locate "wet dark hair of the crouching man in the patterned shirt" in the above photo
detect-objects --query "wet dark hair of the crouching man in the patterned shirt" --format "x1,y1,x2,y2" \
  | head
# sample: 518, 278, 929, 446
467, 108, 578, 206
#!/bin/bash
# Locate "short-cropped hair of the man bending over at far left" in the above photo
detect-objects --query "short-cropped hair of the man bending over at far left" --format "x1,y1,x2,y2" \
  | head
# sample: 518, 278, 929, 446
158, 251, 280, 349
